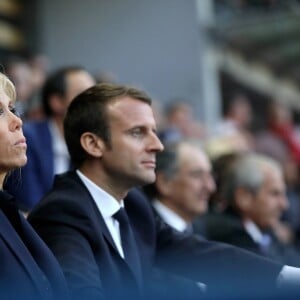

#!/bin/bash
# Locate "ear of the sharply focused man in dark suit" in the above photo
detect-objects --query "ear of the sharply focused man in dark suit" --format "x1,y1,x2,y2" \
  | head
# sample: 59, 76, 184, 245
80, 132, 105, 157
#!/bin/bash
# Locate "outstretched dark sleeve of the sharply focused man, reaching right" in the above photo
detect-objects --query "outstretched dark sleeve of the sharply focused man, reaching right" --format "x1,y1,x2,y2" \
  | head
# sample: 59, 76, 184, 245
156, 218, 283, 298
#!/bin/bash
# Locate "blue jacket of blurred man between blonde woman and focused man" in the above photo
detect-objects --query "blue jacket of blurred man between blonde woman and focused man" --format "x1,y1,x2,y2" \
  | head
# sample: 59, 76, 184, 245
5, 121, 54, 211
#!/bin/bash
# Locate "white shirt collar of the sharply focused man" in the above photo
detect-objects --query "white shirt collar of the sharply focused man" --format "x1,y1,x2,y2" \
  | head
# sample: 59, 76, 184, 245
76, 170, 124, 219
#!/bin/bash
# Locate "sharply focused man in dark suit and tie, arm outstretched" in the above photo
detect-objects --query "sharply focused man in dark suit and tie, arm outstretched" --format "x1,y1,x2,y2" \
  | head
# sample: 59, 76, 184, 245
29, 84, 299, 299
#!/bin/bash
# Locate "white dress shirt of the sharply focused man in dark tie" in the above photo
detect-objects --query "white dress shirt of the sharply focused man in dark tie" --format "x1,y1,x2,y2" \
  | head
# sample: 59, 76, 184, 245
76, 170, 124, 258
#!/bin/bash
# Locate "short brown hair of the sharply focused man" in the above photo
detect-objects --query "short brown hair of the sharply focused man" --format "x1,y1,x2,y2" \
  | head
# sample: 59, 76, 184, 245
64, 83, 152, 167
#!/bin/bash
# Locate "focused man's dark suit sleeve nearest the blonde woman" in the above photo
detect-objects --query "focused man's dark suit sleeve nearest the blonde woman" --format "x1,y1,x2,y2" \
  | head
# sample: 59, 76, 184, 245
29, 199, 105, 300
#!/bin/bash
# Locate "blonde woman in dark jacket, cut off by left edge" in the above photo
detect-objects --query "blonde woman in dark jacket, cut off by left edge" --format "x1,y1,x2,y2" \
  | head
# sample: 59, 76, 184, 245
0, 73, 68, 300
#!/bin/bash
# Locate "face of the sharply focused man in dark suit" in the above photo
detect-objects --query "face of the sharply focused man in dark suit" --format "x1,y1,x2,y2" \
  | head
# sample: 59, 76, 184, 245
101, 97, 163, 189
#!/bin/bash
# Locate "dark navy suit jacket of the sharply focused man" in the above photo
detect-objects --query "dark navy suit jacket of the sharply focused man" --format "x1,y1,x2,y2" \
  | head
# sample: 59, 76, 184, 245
29, 172, 282, 299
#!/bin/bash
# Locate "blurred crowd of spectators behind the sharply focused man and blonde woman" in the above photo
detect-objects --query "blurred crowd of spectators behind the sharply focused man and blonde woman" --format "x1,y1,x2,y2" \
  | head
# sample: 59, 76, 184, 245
3, 54, 300, 298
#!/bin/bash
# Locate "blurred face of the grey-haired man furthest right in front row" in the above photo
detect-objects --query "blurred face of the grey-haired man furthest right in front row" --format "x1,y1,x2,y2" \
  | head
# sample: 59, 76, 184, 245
248, 169, 288, 229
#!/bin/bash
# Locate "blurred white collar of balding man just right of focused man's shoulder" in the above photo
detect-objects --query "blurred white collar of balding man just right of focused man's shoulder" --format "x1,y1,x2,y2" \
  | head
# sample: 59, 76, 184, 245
153, 200, 188, 232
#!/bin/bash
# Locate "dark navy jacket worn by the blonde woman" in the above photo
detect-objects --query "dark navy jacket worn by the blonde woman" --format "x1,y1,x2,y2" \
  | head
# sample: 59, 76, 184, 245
0, 192, 68, 300
